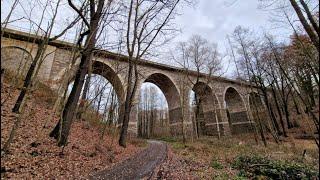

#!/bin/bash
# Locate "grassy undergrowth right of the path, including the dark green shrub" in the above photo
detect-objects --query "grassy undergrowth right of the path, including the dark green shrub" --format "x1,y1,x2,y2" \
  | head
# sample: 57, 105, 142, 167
161, 135, 319, 180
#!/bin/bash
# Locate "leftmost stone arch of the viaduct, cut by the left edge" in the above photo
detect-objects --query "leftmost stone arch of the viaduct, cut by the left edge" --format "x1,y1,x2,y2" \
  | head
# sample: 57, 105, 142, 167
1, 46, 33, 77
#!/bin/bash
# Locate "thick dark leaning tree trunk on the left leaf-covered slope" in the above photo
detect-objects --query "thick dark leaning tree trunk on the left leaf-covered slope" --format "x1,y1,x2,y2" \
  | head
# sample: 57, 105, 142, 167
51, 0, 112, 146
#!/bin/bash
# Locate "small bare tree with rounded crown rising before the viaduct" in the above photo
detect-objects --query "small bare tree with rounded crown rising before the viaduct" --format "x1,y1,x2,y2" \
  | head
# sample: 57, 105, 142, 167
172, 35, 221, 137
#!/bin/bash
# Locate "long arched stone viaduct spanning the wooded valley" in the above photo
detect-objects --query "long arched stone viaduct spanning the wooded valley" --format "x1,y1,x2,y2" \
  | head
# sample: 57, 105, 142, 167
1, 29, 262, 138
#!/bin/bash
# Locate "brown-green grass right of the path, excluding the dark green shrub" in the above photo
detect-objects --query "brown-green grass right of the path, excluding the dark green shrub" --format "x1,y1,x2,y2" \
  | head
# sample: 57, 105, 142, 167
164, 135, 319, 180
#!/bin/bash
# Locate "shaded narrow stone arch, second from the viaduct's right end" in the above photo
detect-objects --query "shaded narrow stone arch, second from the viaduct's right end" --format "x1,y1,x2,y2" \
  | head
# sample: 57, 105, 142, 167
224, 87, 253, 134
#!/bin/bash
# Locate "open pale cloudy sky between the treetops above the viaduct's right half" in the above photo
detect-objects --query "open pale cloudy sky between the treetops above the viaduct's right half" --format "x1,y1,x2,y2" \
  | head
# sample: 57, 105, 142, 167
160, 0, 298, 77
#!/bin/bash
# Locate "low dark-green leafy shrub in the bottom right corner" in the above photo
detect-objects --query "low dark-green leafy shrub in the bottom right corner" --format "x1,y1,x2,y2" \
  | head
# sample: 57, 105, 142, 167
232, 155, 319, 179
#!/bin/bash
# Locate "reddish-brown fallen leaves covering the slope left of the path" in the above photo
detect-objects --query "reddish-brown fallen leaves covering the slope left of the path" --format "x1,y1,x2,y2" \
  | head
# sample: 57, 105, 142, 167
1, 84, 142, 179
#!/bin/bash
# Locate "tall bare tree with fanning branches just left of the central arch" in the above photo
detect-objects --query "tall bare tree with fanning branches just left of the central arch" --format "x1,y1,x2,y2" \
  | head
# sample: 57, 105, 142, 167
119, 0, 184, 147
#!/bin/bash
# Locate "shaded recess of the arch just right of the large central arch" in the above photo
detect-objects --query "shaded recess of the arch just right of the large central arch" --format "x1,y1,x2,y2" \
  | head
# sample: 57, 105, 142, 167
192, 82, 223, 136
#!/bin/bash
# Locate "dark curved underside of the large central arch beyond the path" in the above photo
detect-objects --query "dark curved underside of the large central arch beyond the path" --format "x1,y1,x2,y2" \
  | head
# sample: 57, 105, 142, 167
143, 73, 182, 135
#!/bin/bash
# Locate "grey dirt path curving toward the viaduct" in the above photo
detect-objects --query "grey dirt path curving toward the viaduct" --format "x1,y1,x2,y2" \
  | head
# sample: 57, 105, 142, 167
90, 141, 167, 180
